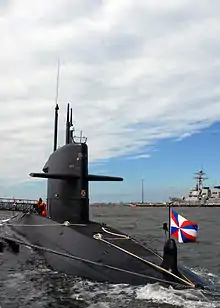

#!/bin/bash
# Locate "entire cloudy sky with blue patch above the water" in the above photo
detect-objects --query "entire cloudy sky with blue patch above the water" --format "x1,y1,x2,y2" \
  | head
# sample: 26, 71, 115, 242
0, 0, 220, 202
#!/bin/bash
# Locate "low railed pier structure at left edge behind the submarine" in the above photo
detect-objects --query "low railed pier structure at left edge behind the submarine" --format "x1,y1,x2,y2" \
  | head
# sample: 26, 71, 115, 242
0, 198, 37, 211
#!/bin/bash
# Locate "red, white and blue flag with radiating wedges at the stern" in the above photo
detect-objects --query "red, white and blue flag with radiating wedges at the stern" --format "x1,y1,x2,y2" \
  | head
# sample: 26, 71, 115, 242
170, 209, 199, 243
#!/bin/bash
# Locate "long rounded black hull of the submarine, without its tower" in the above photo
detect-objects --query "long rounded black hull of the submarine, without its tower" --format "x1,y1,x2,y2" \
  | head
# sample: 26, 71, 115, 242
9, 213, 209, 288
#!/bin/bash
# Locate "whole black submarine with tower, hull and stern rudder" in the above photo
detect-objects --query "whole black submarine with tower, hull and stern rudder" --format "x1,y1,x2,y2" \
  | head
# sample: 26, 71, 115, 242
1, 104, 211, 290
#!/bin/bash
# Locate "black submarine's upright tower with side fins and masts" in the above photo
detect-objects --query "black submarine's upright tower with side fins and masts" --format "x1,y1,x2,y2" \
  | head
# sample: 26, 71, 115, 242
30, 104, 123, 223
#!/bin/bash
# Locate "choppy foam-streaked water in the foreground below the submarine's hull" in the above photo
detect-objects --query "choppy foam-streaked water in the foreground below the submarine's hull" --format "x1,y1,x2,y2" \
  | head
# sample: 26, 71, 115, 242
0, 248, 220, 308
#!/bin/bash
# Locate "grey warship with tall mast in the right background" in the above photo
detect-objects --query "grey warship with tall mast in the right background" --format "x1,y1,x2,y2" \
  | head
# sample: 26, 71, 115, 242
170, 169, 220, 206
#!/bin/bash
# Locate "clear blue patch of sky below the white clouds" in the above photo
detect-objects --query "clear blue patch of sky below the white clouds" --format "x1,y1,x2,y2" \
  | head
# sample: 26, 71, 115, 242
90, 122, 220, 201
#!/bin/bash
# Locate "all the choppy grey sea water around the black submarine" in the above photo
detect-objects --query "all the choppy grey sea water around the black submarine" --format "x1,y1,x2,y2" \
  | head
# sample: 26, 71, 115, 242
0, 206, 220, 308
